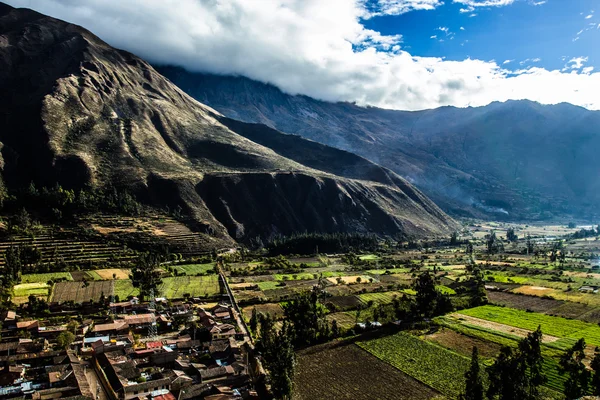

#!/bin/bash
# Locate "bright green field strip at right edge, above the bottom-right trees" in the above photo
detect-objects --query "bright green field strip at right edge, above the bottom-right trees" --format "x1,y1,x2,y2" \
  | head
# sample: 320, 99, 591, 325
460, 305, 600, 346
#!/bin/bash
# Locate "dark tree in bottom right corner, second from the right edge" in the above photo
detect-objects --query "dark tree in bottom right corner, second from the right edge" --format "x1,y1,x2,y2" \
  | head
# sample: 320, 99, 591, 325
559, 338, 590, 400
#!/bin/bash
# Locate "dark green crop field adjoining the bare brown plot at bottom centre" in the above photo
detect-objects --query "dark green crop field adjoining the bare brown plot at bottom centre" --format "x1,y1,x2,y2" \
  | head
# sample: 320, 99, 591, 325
357, 333, 470, 398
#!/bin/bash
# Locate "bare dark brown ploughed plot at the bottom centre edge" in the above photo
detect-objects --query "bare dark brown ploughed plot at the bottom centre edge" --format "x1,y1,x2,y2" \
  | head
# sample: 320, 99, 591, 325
293, 344, 439, 400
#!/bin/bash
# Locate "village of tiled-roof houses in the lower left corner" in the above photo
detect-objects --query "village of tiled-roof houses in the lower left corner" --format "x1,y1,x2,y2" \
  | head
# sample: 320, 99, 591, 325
0, 296, 264, 400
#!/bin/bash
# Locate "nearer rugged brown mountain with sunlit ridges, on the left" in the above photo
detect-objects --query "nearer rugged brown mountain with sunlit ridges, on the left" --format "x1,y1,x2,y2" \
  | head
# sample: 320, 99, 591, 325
0, 3, 456, 245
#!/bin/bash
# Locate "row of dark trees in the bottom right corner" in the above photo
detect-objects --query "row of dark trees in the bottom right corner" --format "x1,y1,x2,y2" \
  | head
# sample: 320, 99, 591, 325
460, 327, 600, 400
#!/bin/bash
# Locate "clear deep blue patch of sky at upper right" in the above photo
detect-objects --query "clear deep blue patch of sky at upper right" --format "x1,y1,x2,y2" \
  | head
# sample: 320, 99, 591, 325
364, 0, 600, 69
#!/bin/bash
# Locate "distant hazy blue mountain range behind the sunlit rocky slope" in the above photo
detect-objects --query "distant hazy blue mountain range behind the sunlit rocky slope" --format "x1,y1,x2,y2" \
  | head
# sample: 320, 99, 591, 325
158, 66, 600, 219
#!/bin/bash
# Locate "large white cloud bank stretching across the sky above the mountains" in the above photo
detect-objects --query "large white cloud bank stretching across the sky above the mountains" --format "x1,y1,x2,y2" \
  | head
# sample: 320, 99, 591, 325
8, 0, 600, 110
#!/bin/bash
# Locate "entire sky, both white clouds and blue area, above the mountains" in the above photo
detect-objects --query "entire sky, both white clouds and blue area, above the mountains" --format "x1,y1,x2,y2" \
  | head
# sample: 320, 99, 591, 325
4, 0, 600, 110
